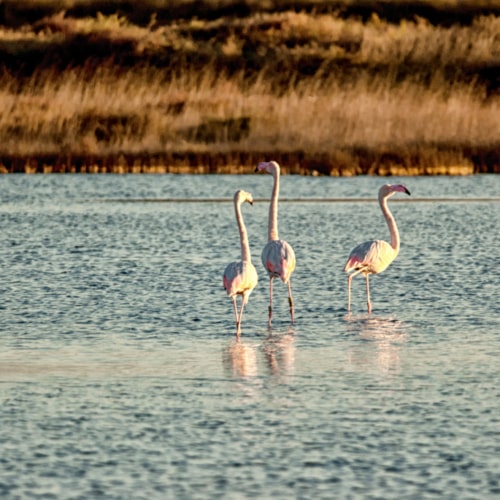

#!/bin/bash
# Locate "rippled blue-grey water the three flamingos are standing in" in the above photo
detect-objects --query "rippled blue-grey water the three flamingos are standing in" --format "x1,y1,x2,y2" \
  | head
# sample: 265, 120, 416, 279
0, 175, 500, 499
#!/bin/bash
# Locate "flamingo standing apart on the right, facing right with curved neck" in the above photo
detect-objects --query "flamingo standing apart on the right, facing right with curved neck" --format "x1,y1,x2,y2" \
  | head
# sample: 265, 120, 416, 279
344, 184, 410, 313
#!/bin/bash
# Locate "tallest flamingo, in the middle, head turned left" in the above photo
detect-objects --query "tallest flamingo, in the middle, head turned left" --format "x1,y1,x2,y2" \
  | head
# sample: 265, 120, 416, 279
255, 161, 295, 328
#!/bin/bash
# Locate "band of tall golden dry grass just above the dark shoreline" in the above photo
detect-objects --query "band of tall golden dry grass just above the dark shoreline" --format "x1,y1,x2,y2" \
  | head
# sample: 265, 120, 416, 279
0, 68, 500, 154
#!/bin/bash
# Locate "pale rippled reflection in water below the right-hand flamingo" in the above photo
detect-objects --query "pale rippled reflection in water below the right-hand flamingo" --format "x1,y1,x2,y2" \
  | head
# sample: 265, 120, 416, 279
346, 316, 408, 374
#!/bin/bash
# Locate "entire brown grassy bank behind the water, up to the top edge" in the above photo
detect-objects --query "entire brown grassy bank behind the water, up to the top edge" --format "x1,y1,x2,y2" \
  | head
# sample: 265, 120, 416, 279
0, 0, 500, 175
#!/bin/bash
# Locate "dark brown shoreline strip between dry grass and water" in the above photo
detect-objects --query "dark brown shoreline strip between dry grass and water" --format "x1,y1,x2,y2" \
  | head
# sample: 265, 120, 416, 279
0, 148, 500, 177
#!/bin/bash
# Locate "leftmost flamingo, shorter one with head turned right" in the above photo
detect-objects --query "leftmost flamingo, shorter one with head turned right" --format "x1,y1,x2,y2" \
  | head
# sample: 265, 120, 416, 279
223, 190, 258, 336
